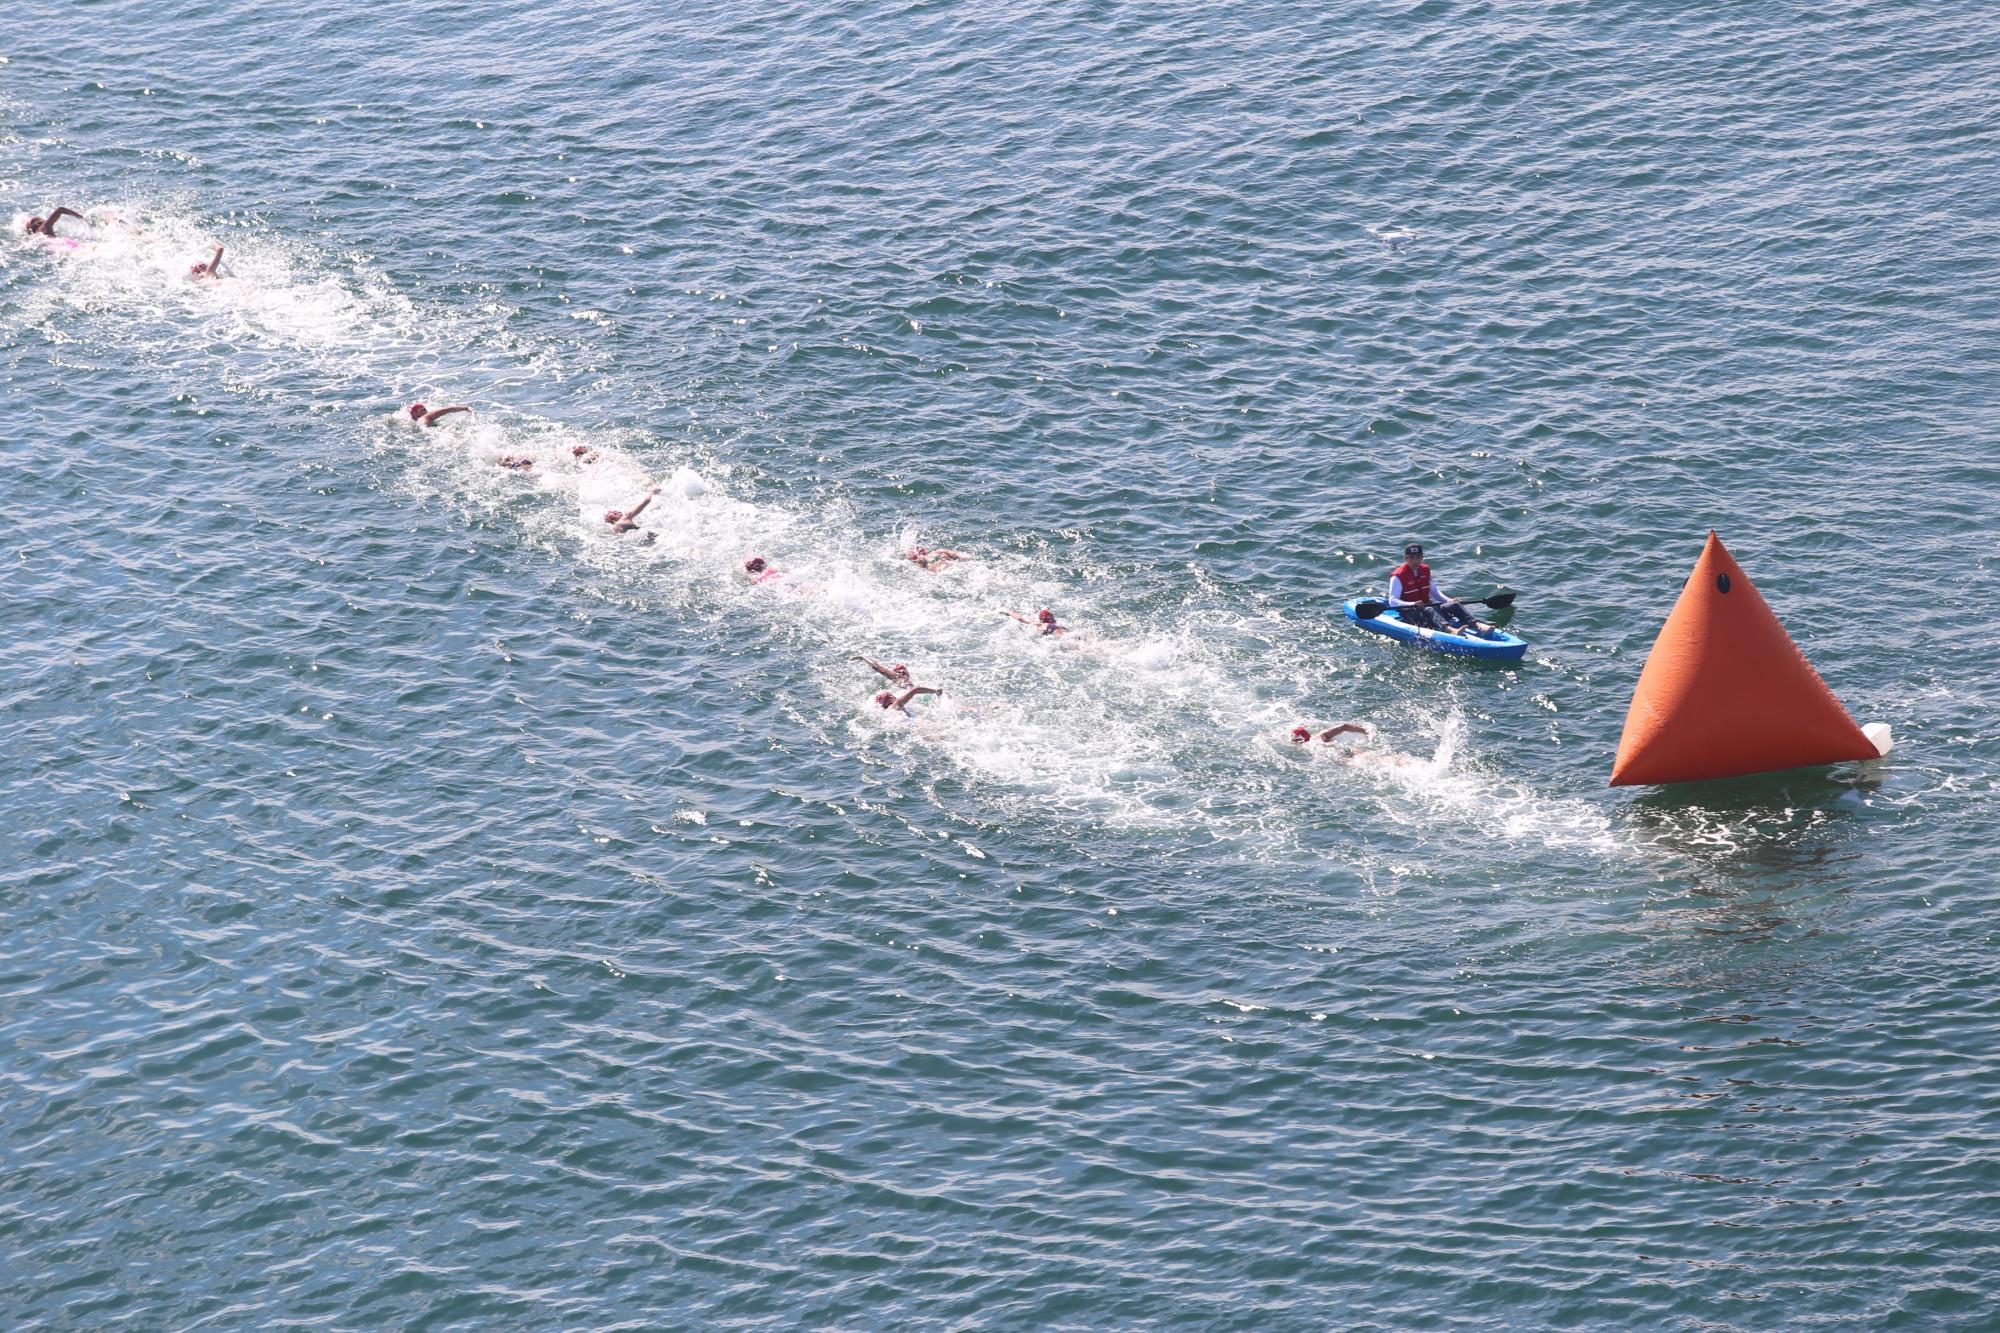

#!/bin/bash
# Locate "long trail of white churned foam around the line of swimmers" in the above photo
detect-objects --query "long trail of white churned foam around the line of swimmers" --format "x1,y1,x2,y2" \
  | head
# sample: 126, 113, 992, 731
6, 195, 1630, 859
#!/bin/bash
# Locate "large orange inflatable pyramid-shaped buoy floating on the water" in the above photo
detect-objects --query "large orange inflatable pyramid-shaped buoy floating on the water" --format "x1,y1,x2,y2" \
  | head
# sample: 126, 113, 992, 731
1612, 532, 1888, 787
